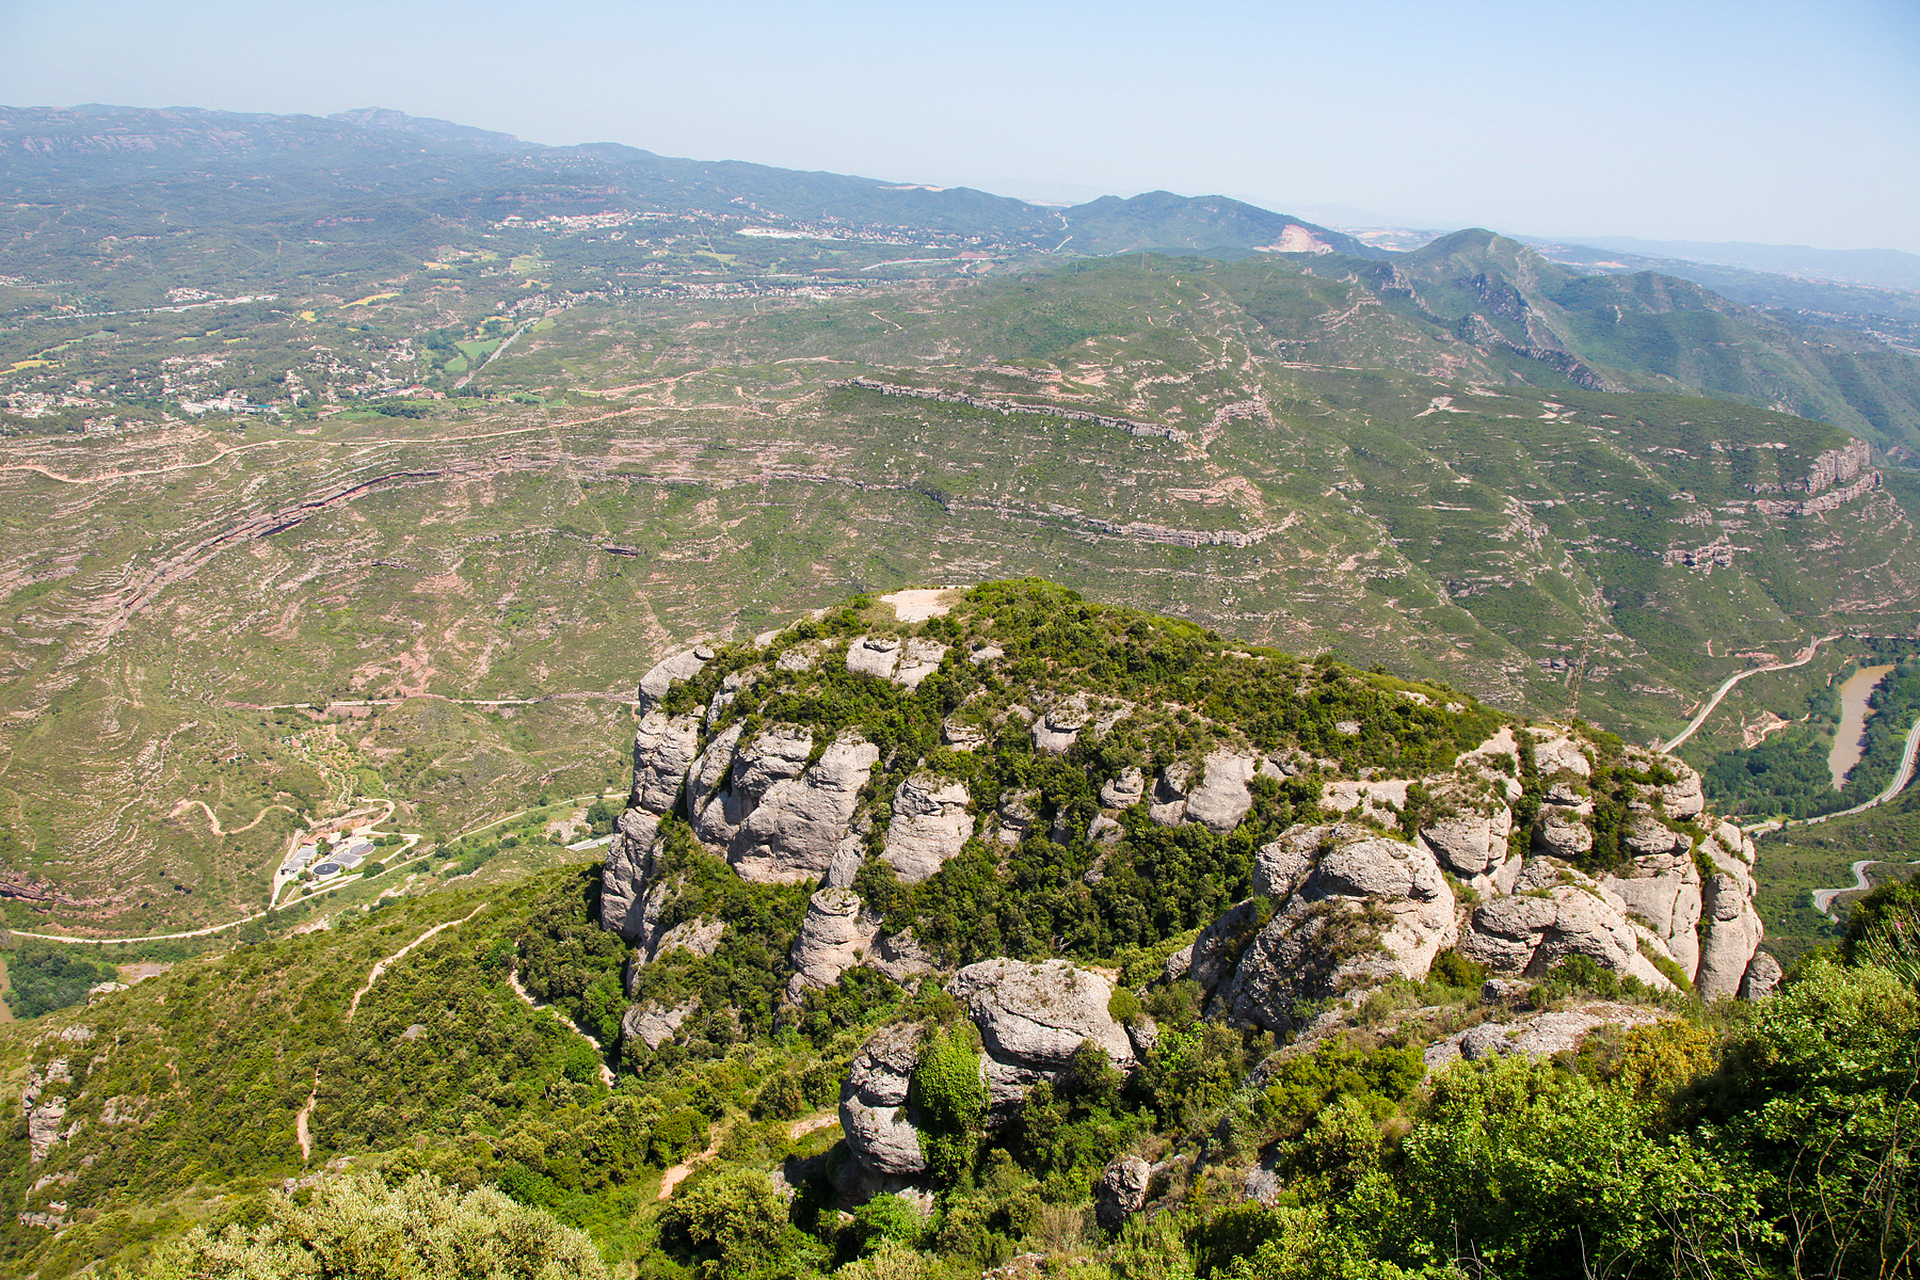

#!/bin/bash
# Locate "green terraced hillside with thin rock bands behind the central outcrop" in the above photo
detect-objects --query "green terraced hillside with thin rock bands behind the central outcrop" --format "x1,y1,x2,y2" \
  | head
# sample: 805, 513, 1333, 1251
0, 247, 1920, 931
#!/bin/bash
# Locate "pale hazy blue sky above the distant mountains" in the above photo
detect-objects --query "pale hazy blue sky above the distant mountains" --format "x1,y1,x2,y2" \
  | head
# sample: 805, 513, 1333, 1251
0, 0, 1920, 251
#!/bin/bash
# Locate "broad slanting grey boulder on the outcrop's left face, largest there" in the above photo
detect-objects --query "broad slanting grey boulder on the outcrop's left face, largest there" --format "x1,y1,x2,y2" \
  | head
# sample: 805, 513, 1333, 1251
728, 729, 879, 885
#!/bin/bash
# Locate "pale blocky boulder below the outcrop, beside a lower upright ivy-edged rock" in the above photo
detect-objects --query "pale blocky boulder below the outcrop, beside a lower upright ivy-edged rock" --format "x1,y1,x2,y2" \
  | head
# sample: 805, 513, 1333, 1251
947, 960, 1133, 1073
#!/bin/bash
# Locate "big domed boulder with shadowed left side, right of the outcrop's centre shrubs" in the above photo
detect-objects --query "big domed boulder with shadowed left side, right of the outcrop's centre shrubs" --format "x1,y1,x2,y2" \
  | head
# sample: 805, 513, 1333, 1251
1196, 823, 1457, 1031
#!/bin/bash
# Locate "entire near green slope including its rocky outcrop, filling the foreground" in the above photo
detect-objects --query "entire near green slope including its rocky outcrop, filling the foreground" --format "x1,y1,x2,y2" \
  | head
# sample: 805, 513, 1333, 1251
0, 580, 1920, 1280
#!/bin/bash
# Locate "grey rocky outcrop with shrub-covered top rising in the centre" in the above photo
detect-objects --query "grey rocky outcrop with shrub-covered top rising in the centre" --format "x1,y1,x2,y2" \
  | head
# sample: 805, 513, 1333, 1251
601, 581, 1780, 1178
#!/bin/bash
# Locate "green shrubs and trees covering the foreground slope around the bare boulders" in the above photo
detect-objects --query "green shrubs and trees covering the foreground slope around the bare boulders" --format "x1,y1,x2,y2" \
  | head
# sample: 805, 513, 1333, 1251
0, 610, 1920, 1280
